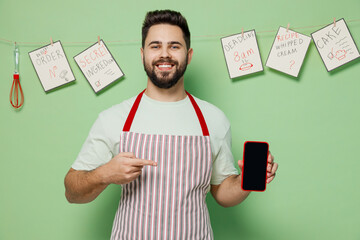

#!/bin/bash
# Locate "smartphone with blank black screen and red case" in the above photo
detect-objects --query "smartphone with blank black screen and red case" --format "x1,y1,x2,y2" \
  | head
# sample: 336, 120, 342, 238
241, 141, 269, 192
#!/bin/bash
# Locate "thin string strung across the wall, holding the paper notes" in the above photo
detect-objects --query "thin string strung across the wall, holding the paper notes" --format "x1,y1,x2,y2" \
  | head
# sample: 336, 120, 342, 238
0, 19, 360, 45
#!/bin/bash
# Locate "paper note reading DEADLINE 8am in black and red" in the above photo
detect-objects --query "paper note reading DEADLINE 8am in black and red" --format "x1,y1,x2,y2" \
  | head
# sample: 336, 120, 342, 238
221, 30, 264, 78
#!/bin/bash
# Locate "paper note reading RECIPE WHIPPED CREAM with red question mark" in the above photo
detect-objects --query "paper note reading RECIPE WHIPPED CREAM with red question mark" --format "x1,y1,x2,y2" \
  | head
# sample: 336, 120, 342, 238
266, 27, 311, 77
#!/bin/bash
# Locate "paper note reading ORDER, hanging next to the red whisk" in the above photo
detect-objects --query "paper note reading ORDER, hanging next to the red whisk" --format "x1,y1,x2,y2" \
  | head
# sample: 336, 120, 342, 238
29, 41, 75, 92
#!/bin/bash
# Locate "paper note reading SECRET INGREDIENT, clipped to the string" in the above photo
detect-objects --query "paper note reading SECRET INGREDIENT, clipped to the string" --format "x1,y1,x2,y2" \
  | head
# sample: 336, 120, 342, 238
74, 40, 124, 92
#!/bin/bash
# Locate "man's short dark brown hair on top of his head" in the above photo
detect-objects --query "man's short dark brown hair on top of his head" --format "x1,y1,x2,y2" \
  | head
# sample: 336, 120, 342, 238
142, 10, 190, 49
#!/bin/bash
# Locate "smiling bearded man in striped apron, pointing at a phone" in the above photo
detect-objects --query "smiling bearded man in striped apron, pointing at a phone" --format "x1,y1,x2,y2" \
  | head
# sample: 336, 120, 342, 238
65, 10, 277, 239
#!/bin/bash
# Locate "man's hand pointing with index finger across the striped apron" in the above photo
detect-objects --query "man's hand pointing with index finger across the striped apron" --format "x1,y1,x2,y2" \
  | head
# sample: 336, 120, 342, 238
99, 153, 157, 184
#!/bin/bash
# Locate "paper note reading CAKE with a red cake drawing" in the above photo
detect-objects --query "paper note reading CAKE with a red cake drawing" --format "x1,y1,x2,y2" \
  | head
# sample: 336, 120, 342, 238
311, 19, 360, 72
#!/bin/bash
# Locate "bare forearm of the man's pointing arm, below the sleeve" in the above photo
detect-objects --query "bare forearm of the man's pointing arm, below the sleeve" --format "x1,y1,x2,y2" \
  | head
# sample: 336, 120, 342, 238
65, 169, 108, 203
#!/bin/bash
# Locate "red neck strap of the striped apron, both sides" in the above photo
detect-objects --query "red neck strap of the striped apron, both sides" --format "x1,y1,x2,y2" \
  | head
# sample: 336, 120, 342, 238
123, 89, 209, 136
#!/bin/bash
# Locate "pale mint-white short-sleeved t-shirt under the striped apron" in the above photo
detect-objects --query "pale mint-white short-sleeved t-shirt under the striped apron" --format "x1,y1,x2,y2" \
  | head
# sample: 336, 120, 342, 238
72, 94, 238, 185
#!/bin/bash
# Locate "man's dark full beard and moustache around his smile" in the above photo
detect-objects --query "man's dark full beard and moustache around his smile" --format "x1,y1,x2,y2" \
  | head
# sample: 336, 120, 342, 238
144, 58, 187, 89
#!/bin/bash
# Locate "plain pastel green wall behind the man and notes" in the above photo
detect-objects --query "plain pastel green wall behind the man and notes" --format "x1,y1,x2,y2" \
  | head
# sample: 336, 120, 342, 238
0, 0, 360, 240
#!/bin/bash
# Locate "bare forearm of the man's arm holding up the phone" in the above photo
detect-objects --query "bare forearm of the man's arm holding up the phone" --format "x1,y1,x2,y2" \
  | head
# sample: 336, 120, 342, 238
211, 175, 250, 207
